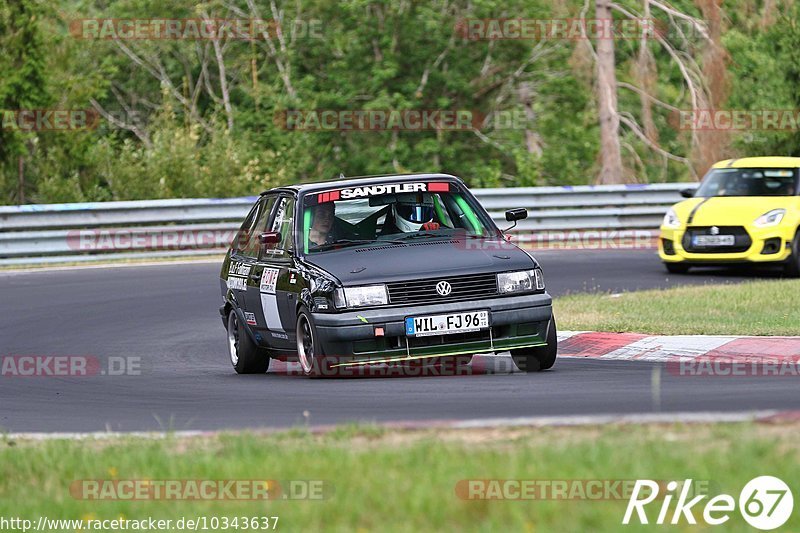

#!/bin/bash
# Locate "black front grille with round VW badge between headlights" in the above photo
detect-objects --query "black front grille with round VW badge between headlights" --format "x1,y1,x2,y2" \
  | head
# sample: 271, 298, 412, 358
386, 274, 497, 305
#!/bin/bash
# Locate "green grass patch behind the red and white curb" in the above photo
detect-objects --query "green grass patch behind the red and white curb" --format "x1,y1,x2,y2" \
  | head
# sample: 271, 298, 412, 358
555, 280, 800, 335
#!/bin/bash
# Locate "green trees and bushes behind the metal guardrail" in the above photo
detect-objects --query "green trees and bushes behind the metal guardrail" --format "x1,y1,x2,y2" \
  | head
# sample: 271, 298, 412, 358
0, 0, 800, 203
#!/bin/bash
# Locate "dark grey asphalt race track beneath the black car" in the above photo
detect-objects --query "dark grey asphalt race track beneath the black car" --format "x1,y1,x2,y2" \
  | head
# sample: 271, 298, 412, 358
0, 250, 800, 432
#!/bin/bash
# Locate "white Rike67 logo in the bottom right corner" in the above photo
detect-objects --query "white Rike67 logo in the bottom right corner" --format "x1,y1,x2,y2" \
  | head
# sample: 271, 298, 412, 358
622, 476, 794, 531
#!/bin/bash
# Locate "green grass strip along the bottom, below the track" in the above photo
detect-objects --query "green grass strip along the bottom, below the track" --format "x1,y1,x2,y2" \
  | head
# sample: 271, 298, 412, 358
0, 424, 800, 531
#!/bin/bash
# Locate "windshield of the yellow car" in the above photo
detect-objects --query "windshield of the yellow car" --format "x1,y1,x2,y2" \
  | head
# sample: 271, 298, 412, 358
695, 168, 797, 198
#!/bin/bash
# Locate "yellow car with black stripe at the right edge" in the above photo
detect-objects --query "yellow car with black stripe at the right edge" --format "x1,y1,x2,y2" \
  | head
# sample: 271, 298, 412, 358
658, 157, 800, 276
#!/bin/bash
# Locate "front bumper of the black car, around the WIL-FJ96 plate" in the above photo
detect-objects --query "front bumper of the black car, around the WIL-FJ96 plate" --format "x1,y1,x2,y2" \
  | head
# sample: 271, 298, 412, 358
313, 293, 553, 366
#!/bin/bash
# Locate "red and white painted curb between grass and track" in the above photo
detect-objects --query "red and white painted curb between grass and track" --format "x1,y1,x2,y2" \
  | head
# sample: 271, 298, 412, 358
558, 331, 800, 362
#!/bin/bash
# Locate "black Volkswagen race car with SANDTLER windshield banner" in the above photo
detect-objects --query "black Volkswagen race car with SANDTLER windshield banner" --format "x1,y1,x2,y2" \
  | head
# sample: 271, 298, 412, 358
219, 174, 557, 376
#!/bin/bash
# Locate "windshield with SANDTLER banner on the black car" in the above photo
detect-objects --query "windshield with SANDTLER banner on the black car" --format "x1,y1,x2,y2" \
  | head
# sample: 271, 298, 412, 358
301, 182, 497, 254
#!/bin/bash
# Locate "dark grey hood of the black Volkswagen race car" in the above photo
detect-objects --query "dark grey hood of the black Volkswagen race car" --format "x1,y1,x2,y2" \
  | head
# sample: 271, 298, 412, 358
305, 239, 536, 285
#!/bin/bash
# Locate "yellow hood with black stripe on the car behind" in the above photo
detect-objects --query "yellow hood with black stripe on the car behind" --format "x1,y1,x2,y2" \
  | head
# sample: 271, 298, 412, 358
674, 196, 795, 226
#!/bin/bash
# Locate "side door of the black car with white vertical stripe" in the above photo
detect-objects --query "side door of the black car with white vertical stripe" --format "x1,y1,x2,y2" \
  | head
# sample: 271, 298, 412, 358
248, 194, 302, 351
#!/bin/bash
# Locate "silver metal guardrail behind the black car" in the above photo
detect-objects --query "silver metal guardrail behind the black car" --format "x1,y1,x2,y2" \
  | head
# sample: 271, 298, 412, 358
0, 183, 690, 265
